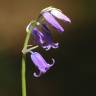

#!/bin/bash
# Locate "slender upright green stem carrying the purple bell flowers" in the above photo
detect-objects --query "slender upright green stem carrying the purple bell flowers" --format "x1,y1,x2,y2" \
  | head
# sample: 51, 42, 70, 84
21, 21, 36, 96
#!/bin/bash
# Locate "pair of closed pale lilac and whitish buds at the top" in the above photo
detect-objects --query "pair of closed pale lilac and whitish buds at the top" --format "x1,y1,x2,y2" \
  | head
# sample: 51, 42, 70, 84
41, 7, 71, 32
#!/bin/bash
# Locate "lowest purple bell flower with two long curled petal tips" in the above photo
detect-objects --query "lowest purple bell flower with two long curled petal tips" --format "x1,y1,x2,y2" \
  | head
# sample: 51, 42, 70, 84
31, 52, 55, 77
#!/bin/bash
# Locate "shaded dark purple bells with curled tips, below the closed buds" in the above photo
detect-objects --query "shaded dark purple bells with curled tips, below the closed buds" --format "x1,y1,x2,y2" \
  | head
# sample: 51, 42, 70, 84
32, 24, 59, 51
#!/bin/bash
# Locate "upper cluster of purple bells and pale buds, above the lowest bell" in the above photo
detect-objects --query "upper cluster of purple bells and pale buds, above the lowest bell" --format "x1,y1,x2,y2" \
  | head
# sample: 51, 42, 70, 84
27, 7, 71, 51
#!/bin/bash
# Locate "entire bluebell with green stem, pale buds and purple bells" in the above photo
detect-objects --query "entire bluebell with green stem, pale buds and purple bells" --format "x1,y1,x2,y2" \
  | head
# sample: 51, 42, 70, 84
21, 6, 71, 96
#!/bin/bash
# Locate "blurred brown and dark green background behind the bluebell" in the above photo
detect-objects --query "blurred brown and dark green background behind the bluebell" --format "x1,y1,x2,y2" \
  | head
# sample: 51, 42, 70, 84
0, 0, 96, 96
